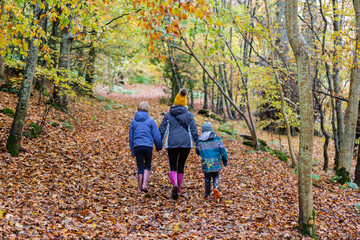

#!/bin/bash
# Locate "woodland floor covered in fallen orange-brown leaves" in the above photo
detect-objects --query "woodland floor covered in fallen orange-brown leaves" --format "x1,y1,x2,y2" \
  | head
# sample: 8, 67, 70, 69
0, 83, 360, 239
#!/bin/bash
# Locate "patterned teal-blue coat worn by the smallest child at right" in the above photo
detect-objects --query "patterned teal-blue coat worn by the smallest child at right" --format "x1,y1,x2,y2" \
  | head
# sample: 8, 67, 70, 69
195, 132, 228, 173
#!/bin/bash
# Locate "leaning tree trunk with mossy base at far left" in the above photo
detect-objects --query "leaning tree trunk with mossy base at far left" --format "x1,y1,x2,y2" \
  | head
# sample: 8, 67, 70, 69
6, 4, 45, 156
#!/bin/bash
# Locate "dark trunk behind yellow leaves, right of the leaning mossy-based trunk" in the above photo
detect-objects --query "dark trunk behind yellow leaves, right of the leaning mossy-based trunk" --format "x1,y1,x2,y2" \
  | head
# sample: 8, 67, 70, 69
53, 11, 74, 111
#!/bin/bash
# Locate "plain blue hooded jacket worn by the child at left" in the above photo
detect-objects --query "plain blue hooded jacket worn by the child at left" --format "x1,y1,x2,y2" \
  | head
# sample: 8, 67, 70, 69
129, 111, 162, 156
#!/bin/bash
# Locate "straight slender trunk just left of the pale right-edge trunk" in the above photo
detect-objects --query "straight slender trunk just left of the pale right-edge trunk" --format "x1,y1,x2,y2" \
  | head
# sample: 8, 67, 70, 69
332, 0, 344, 167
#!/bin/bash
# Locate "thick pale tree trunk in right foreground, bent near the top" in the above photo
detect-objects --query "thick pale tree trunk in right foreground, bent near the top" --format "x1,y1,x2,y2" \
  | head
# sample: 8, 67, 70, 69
286, 0, 316, 237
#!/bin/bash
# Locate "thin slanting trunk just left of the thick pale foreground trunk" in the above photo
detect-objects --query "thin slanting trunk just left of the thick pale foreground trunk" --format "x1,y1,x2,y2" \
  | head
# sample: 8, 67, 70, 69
264, 0, 296, 168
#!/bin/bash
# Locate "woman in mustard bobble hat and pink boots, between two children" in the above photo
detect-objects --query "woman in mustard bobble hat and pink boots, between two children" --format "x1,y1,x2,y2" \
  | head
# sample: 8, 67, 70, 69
159, 88, 198, 200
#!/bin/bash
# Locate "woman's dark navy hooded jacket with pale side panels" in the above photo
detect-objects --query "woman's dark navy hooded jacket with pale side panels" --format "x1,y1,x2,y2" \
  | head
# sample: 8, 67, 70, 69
159, 105, 198, 148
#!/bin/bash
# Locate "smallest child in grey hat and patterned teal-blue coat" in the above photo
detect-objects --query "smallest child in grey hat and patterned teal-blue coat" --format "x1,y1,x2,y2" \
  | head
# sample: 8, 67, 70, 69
196, 122, 228, 200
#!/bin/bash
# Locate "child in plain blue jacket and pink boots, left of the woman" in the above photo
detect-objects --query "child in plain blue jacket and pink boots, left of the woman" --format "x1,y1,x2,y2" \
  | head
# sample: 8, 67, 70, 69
129, 102, 162, 194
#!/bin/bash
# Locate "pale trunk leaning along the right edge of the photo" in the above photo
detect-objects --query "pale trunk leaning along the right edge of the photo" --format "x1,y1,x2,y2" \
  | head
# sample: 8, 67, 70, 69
339, 0, 360, 174
